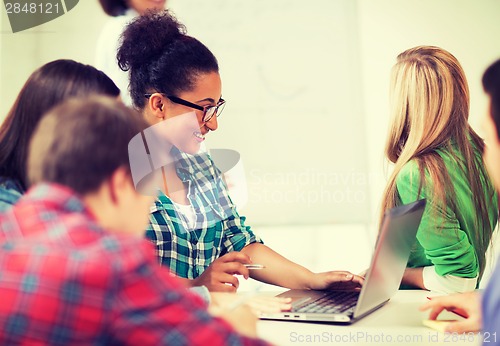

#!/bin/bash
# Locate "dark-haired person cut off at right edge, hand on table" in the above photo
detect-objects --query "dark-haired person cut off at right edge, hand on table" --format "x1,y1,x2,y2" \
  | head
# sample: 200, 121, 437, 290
421, 60, 500, 345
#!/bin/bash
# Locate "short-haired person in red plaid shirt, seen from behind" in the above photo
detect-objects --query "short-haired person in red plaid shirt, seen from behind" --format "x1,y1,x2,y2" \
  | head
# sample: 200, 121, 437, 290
0, 96, 265, 345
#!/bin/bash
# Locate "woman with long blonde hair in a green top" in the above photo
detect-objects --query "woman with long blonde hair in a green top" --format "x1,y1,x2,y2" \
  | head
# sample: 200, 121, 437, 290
382, 46, 498, 293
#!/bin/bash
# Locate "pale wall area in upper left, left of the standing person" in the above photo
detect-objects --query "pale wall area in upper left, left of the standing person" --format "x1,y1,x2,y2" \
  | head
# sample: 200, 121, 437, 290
0, 0, 106, 120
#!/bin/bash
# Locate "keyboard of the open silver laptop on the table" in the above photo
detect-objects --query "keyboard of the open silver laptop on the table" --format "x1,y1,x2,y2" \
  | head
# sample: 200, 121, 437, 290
293, 291, 359, 314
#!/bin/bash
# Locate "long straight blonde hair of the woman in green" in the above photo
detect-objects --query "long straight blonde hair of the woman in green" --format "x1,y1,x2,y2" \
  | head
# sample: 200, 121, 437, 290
382, 46, 494, 277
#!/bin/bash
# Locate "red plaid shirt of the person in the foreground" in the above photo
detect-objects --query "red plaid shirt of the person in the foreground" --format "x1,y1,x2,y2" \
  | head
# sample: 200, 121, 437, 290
0, 185, 270, 345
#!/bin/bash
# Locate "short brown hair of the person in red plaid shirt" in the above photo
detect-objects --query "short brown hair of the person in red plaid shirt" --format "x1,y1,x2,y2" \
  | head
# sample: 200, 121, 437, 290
28, 96, 147, 195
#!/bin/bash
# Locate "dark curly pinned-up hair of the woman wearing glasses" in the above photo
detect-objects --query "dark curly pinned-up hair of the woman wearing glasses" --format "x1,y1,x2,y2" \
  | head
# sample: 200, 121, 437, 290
117, 10, 219, 108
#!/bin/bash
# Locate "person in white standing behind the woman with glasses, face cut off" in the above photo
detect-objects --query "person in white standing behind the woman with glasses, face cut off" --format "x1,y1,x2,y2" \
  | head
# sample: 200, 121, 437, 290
95, 0, 167, 106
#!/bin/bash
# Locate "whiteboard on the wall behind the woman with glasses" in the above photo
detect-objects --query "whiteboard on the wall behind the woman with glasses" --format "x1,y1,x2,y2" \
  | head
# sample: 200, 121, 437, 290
170, 0, 370, 225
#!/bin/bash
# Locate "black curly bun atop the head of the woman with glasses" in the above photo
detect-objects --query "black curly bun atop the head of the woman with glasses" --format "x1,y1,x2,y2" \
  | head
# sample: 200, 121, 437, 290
117, 10, 186, 71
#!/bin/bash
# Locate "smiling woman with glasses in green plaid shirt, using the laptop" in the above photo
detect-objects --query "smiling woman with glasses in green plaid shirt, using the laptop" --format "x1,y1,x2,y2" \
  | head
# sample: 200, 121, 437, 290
118, 11, 363, 291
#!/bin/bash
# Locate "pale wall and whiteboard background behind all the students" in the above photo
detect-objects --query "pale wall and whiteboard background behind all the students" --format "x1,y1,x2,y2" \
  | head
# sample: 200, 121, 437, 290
0, 0, 500, 289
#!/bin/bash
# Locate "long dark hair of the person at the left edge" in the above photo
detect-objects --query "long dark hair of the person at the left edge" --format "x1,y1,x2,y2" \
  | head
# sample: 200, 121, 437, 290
0, 60, 120, 189
